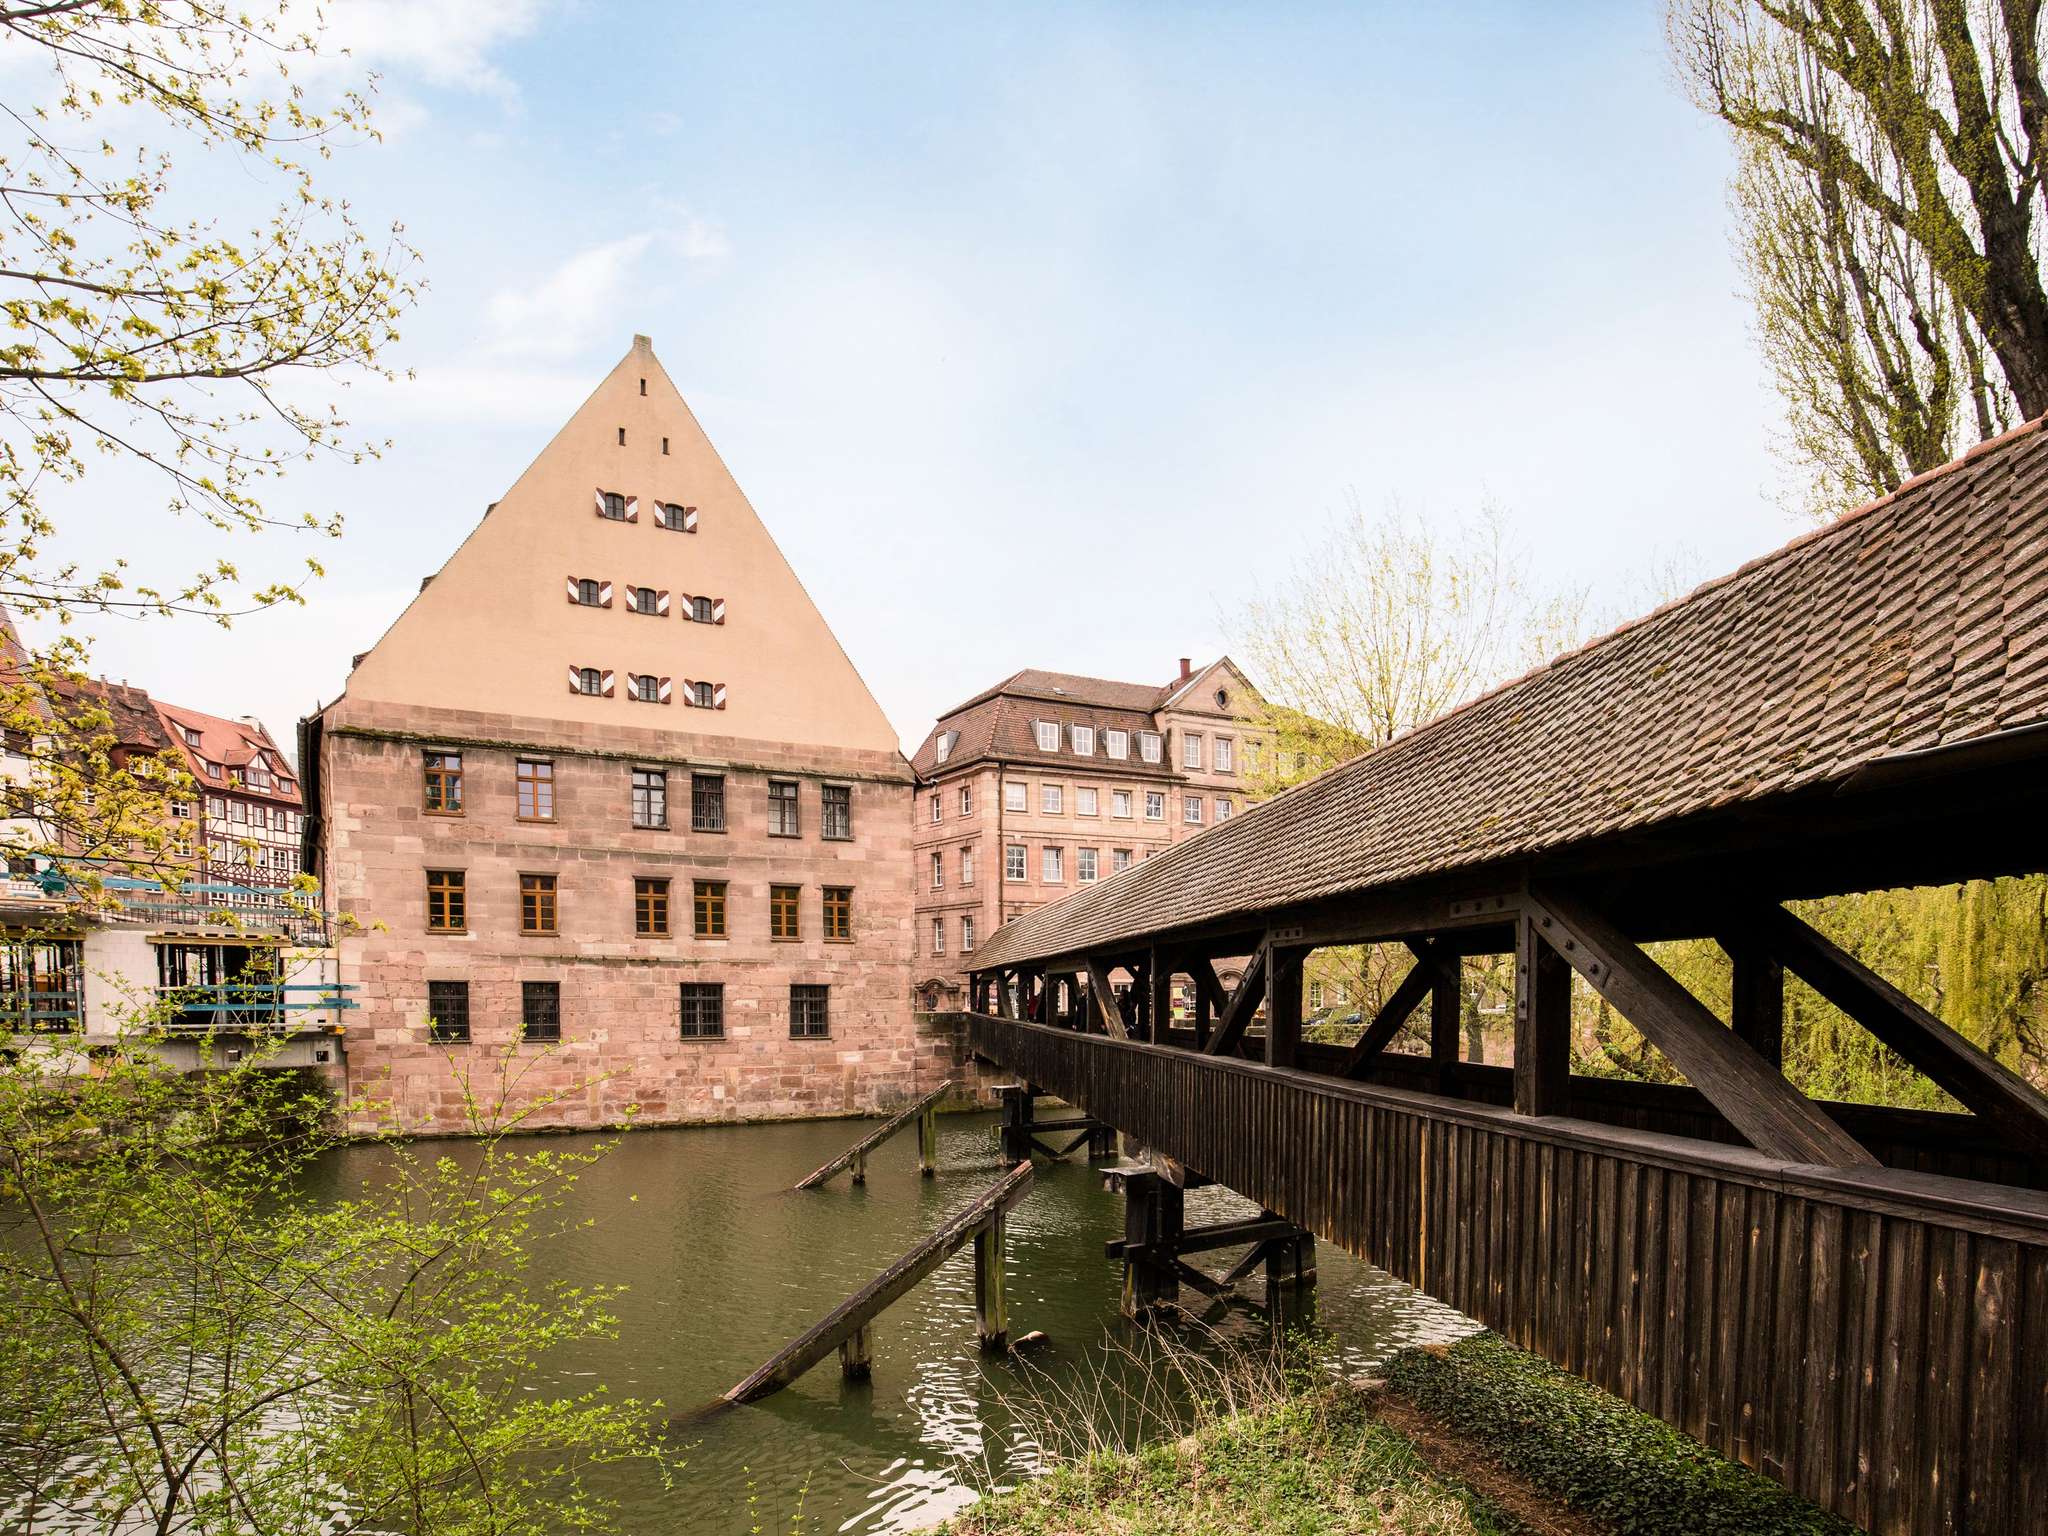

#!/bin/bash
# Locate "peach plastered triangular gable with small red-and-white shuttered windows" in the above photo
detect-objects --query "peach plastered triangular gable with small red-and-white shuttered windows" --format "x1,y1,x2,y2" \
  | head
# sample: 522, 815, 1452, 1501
348, 340, 897, 754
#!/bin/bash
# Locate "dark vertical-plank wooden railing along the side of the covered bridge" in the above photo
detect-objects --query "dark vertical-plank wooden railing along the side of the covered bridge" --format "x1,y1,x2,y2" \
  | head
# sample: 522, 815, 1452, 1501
969, 1014, 2048, 1534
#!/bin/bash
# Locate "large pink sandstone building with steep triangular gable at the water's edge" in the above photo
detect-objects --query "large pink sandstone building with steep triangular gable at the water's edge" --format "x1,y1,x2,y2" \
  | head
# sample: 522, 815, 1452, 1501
299, 338, 917, 1130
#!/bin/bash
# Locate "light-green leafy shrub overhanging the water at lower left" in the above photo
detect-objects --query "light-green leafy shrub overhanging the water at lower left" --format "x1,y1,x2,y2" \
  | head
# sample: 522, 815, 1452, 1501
0, 1030, 662, 1536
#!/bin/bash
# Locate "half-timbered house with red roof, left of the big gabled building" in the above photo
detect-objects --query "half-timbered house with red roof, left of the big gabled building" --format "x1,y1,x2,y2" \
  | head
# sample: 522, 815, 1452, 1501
156, 698, 305, 887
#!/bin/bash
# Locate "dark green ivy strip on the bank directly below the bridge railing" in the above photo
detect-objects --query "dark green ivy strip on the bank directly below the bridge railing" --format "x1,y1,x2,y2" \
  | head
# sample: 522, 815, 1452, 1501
1386, 1333, 1855, 1536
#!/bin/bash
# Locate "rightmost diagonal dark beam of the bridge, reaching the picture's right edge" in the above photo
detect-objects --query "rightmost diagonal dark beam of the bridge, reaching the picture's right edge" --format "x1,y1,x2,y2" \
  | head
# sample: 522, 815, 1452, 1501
1757, 907, 2048, 1153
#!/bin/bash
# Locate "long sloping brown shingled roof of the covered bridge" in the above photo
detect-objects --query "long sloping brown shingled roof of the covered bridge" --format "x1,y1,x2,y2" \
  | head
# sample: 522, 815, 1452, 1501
973, 422, 2048, 971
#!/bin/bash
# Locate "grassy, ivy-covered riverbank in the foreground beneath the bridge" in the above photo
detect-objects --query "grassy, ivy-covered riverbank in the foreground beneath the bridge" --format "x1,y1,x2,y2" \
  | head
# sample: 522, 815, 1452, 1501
944, 1333, 1853, 1536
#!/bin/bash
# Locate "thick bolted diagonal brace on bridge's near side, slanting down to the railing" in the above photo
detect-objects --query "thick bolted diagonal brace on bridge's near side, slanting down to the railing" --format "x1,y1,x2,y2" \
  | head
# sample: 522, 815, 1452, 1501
1516, 889, 1878, 1167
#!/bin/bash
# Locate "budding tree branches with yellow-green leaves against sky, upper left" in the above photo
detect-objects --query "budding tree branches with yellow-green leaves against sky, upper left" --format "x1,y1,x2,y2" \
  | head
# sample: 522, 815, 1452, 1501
0, 0, 414, 909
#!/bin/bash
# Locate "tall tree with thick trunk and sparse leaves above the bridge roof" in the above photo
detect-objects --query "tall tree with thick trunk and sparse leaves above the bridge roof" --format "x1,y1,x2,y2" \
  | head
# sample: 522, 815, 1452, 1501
1669, 0, 2048, 514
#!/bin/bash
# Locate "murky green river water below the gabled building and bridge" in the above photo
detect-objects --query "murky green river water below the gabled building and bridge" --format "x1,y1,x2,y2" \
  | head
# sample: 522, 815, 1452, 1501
324, 1114, 1473, 1536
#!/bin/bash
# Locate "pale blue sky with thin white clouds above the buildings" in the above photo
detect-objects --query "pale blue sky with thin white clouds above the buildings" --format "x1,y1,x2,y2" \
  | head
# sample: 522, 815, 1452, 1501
66, 0, 1798, 765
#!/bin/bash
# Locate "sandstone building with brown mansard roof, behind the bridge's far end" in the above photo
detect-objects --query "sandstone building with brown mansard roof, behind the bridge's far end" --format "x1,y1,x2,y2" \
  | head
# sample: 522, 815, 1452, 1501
911, 657, 1270, 1008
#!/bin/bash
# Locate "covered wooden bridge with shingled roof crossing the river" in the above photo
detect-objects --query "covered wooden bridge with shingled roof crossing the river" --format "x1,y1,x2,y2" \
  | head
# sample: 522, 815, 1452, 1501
969, 424, 2048, 1532
